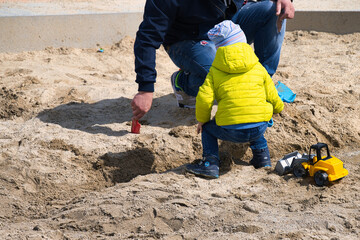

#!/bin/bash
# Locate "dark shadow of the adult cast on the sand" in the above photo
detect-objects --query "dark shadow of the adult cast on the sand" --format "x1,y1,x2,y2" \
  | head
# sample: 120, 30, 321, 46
37, 94, 195, 136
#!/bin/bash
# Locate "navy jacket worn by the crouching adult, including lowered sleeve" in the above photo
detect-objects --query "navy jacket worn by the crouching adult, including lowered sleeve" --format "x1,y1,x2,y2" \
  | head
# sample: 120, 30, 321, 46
134, 0, 244, 92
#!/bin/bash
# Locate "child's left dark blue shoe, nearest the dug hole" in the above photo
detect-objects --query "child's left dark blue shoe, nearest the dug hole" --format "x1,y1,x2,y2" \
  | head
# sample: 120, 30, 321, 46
185, 156, 220, 178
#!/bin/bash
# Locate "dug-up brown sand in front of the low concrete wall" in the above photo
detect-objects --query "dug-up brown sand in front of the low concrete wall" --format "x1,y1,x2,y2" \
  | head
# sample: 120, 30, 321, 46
0, 0, 360, 240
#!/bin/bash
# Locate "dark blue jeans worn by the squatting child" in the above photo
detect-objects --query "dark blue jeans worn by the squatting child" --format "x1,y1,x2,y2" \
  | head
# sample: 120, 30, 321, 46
201, 119, 268, 159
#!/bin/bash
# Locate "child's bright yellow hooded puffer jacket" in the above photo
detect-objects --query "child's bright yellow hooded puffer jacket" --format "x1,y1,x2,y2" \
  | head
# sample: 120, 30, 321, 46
196, 43, 284, 126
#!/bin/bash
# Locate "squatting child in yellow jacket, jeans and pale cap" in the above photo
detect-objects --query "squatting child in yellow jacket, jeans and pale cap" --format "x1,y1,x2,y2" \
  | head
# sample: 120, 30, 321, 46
186, 20, 284, 178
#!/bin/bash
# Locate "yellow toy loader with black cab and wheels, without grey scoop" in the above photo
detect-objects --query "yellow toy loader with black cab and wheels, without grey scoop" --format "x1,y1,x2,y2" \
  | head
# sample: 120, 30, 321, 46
293, 143, 349, 186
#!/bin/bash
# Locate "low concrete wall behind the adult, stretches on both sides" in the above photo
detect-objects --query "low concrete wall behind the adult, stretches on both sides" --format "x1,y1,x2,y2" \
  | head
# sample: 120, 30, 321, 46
0, 11, 360, 52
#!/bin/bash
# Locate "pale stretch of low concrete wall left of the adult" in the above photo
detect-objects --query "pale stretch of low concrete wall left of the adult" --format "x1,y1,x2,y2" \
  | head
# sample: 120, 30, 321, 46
0, 13, 143, 52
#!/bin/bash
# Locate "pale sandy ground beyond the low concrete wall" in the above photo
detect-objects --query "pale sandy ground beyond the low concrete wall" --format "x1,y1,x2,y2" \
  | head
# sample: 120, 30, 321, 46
0, 0, 360, 16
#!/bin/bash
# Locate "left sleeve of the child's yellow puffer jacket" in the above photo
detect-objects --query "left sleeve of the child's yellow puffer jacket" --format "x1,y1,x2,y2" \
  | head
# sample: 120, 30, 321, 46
195, 68, 215, 123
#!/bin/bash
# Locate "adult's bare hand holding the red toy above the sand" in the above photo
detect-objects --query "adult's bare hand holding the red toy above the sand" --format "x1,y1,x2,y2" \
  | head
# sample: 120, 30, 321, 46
131, 91, 153, 120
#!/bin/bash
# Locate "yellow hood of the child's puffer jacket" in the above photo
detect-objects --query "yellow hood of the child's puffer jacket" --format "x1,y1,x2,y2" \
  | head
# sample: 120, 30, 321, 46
213, 43, 259, 73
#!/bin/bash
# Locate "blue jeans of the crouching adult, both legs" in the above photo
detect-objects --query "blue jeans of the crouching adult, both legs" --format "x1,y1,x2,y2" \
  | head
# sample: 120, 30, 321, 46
167, 0, 286, 96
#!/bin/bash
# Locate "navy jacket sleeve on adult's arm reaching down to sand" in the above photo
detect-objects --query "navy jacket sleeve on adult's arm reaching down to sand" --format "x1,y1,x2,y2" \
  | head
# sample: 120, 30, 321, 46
134, 0, 178, 92
